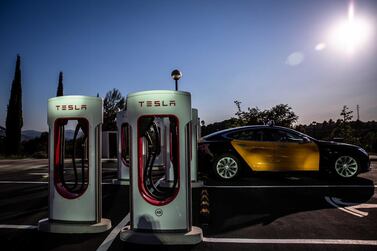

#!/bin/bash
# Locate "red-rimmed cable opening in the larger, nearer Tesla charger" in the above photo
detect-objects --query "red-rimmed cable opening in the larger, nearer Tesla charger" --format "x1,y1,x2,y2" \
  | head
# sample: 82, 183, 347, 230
138, 115, 179, 205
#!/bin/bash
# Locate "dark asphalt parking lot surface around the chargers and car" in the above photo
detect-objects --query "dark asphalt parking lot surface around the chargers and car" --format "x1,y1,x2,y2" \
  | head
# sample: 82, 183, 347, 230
0, 159, 377, 251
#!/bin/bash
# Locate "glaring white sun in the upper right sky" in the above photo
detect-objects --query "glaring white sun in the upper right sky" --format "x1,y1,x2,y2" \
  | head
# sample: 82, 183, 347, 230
330, 3, 371, 54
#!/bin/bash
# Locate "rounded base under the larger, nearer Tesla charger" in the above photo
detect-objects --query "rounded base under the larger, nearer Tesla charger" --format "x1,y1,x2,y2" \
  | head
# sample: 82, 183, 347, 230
120, 225, 203, 245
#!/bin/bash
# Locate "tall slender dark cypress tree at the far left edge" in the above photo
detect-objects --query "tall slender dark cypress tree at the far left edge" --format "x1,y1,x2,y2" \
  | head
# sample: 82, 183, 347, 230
5, 55, 23, 154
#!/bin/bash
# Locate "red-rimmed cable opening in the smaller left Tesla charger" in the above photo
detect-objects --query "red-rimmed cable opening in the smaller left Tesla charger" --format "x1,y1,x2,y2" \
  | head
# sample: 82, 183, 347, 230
54, 119, 89, 199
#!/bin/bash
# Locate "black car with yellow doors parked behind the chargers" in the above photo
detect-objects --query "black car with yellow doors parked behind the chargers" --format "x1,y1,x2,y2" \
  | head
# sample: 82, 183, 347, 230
198, 125, 370, 180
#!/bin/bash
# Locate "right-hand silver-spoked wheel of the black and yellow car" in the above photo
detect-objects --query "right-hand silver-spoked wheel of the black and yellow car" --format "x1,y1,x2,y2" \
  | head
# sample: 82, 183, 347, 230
334, 155, 359, 179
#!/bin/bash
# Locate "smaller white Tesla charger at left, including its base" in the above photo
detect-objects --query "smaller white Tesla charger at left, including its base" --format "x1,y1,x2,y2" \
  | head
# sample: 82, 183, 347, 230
38, 96, 111, 233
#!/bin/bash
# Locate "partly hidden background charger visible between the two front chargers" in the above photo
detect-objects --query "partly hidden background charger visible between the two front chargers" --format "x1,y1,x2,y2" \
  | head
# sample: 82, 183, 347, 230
115, 110, 130, 185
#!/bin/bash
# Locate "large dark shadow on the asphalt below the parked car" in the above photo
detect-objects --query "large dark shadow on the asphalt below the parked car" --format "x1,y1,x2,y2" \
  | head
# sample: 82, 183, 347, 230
201, 174, 375, 235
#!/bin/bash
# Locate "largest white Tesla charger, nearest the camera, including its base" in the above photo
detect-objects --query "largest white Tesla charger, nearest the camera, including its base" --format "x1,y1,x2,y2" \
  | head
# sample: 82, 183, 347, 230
120, 90, 202, 244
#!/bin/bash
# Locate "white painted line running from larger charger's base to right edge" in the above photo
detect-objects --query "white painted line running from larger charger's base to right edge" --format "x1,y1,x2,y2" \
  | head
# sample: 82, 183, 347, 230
203, 237, 377, 246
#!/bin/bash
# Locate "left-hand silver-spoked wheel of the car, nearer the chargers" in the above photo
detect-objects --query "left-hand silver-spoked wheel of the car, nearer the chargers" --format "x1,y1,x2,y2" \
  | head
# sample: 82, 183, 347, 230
213, 154, 241, 180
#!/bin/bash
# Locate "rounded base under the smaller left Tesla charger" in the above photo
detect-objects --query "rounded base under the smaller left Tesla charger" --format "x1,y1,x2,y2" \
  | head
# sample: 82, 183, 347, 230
38, 218, 111, 234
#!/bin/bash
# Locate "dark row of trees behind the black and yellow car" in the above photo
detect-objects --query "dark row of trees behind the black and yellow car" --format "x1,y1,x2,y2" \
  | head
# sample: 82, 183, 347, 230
201, 100, 377, 153
